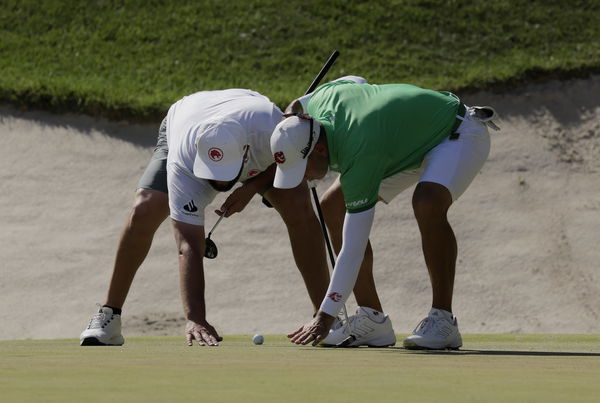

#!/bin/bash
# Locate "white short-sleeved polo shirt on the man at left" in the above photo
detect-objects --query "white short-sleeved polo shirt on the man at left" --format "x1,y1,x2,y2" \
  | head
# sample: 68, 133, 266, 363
167, 89, 283, 225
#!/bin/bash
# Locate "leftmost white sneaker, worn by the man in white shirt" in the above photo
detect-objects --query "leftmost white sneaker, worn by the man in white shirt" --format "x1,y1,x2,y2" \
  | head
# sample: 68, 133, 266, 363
79, 306, 125, 346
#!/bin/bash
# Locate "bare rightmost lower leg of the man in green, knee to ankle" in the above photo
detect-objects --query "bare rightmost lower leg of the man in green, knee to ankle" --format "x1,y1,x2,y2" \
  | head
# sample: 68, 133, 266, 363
412, 182, 457, 312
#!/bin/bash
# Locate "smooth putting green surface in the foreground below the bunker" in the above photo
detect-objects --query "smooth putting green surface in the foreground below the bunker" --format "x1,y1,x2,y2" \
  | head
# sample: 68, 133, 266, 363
0, 335, 600, 402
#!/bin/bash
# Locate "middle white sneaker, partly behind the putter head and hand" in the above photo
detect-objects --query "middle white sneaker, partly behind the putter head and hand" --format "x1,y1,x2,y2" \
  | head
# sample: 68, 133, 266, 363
321, 306, 396, 347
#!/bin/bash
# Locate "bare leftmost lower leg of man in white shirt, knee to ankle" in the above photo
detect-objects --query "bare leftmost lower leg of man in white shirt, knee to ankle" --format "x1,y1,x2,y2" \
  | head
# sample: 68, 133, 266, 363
105, 189, 169, 308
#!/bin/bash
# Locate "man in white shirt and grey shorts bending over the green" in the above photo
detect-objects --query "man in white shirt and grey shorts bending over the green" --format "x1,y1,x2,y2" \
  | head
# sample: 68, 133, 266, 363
80, 89, 329, 346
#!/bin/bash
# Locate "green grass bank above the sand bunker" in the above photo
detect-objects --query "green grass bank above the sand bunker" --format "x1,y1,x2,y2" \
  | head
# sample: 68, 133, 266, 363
0, 0, 600, 120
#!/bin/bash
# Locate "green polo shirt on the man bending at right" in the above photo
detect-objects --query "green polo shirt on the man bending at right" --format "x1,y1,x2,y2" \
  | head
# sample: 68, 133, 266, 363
307, 81, 460, 213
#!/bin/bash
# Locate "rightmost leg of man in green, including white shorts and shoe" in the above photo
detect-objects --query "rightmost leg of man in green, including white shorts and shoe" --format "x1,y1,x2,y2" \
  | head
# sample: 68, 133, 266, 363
403, 113, 490, 349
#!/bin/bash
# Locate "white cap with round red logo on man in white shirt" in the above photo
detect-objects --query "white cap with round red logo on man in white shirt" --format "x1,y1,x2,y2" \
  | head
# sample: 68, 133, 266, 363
194, 119, 246, 181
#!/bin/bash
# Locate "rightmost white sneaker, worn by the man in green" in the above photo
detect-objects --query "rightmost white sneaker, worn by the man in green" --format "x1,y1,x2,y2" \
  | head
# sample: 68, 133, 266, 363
402, 308, 462, 350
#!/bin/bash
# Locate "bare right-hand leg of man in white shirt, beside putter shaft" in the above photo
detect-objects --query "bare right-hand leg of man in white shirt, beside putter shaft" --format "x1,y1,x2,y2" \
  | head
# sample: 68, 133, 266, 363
264, 183, 329, 312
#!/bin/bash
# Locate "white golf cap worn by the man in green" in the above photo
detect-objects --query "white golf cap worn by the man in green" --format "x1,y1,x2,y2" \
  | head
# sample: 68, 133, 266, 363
271, 115, 320, 189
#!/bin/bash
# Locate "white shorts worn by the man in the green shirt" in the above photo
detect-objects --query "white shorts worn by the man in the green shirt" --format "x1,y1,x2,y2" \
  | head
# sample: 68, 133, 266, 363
379, 107, 490, 203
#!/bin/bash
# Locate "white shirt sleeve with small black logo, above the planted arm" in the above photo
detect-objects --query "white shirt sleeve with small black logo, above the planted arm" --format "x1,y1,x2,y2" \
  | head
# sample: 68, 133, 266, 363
167, 164, 217, 226
